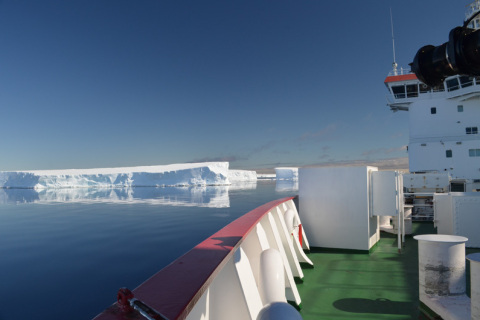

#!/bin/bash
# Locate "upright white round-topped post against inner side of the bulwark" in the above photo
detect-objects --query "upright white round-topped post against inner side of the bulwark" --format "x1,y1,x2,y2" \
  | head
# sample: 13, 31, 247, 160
260, 248, 287, 304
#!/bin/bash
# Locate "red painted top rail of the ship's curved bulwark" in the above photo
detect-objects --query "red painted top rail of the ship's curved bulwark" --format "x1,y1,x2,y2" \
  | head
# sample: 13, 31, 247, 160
94, 197, 293, 320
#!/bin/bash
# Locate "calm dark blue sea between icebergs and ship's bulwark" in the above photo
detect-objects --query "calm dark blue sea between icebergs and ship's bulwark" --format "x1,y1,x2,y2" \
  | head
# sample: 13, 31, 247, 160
0, 180, 297, 320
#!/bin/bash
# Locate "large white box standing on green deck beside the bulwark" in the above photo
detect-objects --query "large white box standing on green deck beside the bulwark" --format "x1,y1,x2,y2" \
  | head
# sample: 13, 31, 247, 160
299, 167, 380, 250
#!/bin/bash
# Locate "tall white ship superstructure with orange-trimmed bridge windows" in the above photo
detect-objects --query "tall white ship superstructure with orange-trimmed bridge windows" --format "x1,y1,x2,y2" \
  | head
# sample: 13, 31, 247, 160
385, 0, 480, 191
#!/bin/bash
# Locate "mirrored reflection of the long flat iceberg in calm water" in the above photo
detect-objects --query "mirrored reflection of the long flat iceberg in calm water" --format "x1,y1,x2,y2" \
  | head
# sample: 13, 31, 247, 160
0, 186, 231, 208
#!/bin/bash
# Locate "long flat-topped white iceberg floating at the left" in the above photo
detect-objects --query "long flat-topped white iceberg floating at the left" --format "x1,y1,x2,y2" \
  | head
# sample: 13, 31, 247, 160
0, 162, 256, 189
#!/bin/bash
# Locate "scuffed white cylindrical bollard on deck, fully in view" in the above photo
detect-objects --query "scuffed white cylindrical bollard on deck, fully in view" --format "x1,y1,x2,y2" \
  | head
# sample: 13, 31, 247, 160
414, 234, 468, 298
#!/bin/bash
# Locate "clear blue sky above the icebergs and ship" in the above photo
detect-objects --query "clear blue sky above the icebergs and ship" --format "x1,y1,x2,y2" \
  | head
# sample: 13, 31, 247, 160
0, 0, 469, 171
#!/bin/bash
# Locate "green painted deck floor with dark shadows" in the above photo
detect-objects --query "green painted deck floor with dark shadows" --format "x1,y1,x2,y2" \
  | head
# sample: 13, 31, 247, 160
297, 222, 480, 320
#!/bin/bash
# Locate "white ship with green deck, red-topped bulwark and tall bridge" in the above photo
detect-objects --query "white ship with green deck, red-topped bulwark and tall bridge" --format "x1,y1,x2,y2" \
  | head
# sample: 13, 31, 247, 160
94, 0, 480, 320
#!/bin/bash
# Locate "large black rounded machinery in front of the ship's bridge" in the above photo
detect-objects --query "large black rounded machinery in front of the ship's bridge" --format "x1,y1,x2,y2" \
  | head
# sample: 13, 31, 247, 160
410, 27, 480, 87
